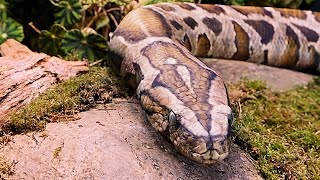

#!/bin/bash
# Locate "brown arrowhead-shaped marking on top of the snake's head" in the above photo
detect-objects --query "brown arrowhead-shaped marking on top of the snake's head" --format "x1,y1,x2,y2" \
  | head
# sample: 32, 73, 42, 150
142, 42, 216, 131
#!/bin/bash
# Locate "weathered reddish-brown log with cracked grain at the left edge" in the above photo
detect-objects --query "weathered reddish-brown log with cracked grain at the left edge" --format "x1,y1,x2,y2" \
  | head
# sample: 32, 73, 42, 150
0, 39, 89, 121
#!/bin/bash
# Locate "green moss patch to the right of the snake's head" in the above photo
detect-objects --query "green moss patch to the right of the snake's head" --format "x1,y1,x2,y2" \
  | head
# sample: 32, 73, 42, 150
229, 79, 320, 179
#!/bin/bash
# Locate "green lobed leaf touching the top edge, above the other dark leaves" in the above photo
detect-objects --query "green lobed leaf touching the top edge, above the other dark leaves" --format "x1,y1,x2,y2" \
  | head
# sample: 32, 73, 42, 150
52, 0, 82, 26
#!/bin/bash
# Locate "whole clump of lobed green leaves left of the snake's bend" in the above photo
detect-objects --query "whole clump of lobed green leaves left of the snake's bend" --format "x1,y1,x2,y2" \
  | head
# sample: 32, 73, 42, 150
38, 0, 113, 61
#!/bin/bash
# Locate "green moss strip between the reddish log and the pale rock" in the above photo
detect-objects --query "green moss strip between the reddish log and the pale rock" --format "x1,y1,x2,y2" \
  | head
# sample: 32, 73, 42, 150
6, 68, 127, 133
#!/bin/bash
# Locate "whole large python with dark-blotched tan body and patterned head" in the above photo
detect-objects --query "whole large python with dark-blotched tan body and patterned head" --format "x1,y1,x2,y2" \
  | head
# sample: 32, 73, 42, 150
109, 3, 320, 164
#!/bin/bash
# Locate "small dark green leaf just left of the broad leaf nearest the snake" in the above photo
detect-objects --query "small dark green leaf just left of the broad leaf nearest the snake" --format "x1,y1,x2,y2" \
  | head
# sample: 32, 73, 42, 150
38, 24, 67, 55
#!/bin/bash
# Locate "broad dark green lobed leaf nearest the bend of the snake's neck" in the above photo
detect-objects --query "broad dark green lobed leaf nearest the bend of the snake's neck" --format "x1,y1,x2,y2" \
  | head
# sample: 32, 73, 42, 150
61, 29, 108, 61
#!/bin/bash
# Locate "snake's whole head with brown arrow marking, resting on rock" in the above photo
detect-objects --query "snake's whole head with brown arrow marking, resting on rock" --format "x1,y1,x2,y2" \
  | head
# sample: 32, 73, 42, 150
135, 41, 232, 164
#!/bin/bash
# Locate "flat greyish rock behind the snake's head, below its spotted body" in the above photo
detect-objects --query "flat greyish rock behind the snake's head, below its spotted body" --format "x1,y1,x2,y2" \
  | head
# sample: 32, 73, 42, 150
202, 58, 313, 92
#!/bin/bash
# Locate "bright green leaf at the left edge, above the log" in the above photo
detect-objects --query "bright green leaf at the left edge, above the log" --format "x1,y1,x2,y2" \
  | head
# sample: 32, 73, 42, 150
0, 18, 24, 44
